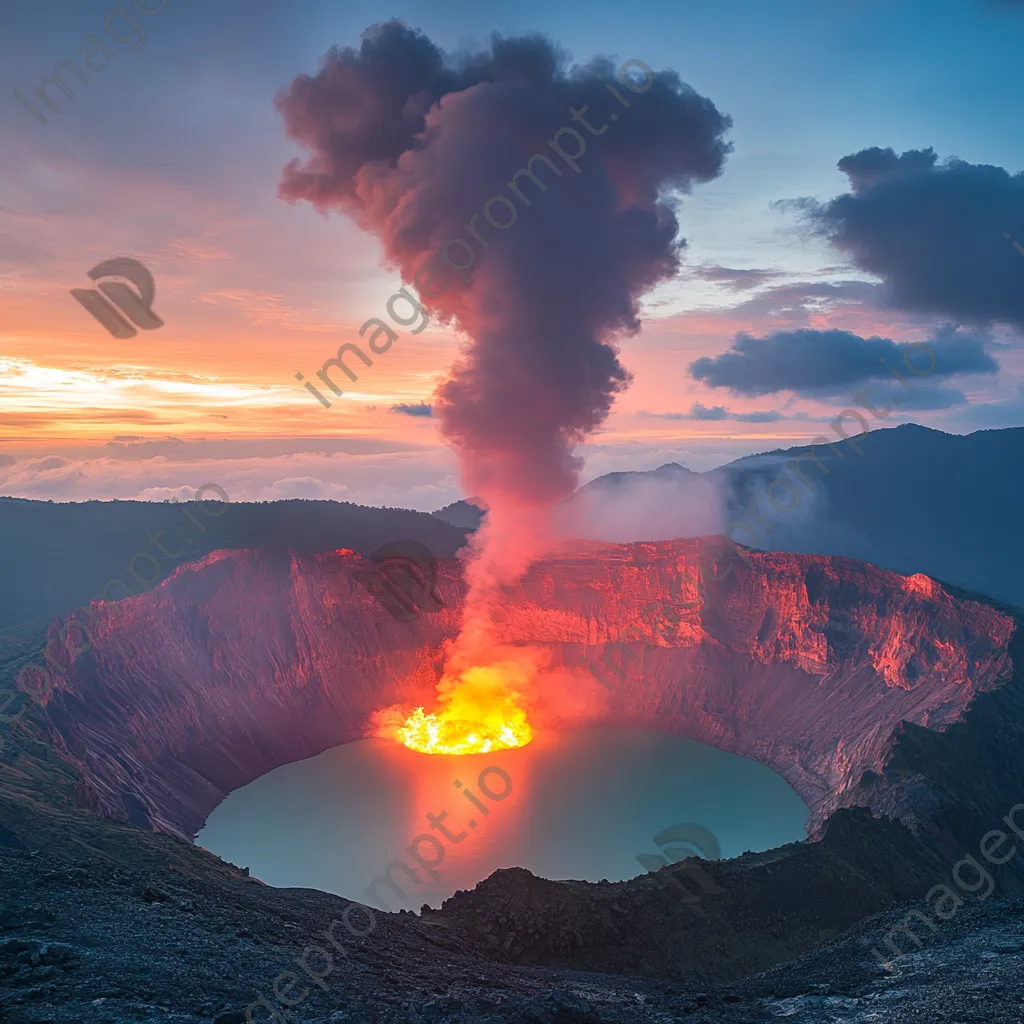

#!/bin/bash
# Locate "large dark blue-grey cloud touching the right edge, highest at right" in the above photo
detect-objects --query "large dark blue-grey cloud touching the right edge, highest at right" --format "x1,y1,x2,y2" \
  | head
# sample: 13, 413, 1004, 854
798, 147, 1024, 327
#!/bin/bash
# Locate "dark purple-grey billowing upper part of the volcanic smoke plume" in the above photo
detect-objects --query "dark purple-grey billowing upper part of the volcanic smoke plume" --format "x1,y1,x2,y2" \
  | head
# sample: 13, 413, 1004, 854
278, 22, 730, 503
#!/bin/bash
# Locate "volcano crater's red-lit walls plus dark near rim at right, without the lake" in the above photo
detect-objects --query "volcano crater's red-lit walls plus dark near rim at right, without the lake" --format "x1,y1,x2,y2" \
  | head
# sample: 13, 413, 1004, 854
18, 538, 1024, 979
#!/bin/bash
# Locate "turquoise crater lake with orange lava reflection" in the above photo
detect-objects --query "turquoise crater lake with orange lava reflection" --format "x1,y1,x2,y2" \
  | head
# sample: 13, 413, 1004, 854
196, 728, 808, 910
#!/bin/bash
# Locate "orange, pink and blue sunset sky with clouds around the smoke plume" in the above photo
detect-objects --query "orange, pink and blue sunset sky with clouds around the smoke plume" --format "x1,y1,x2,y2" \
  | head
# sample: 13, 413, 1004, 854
0, 0, 1024, 510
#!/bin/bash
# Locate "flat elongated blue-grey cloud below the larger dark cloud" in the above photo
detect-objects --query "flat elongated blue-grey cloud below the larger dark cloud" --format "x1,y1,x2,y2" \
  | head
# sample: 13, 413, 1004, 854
689, 327, 998, 396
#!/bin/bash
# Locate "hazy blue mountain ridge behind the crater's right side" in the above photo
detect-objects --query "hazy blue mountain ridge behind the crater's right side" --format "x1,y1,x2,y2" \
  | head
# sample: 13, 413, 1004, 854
430, 424, 1024, 608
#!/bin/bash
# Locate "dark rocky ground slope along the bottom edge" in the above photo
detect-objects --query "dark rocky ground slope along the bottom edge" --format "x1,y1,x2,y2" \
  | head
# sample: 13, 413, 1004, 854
0, 831, 1024, 1024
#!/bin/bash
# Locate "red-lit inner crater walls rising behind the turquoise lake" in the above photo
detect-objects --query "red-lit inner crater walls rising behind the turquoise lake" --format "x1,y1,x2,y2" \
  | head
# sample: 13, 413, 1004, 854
25, 539, 1015, 838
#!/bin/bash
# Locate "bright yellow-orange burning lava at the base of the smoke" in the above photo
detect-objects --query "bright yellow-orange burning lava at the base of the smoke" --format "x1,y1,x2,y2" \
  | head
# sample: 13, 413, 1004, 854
392, 660, 534, 754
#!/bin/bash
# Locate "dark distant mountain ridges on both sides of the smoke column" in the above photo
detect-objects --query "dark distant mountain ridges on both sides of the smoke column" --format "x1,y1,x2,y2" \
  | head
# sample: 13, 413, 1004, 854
0, 424, 1024, 633
